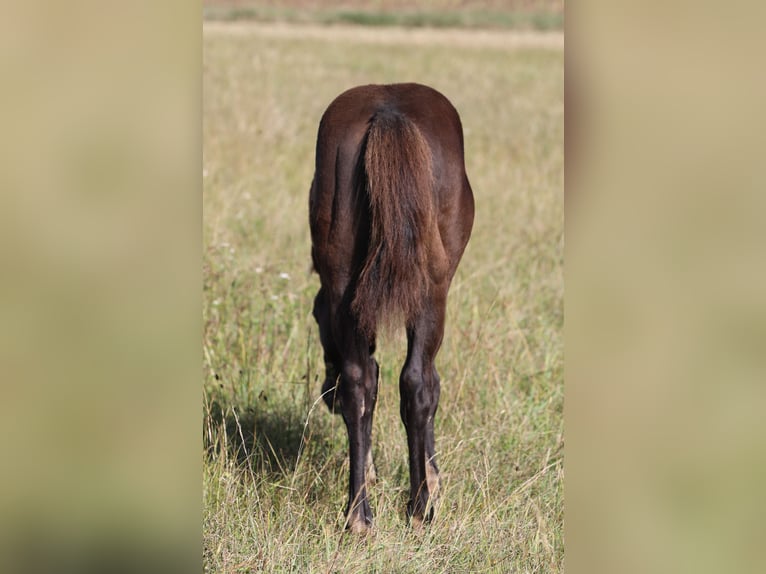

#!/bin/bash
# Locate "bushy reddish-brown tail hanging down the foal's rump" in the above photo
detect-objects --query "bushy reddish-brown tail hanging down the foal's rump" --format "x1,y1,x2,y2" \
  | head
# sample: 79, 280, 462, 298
351, 110, 446, 338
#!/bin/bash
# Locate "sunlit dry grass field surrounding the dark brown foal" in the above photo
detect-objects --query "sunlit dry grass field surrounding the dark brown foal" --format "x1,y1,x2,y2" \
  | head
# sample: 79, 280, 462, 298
203, 20, 564, 573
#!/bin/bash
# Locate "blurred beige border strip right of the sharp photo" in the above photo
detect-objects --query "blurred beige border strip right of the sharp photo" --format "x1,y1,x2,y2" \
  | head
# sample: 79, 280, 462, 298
564, 1, 766, 573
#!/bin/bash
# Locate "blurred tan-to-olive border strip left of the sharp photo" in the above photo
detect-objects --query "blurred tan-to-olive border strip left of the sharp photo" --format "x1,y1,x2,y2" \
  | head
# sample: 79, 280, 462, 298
0, 0, 202, 572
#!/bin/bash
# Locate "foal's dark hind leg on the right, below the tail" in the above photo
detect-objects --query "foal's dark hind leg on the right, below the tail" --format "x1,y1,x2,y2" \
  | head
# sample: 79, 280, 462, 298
399, 286, 447, 523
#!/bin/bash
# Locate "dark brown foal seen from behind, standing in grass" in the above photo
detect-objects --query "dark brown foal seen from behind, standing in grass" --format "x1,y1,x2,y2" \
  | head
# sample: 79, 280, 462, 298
309, 84, 474, 532
